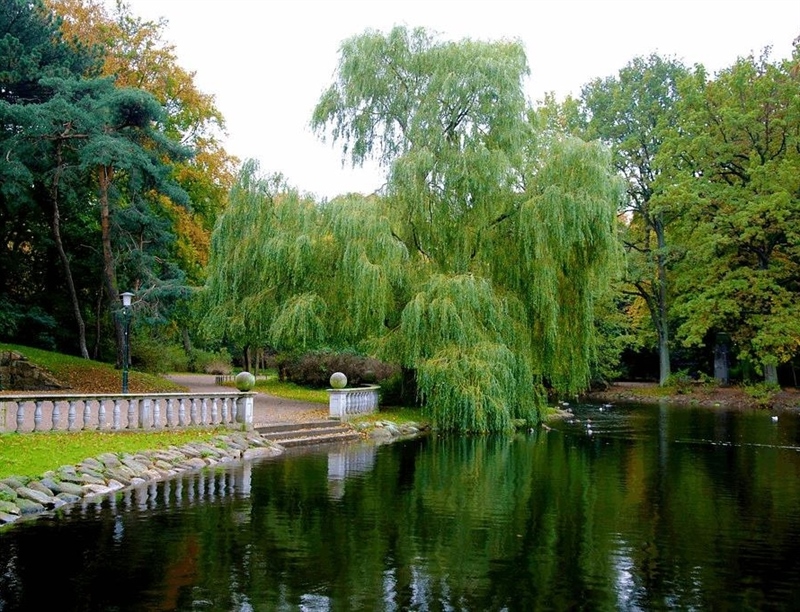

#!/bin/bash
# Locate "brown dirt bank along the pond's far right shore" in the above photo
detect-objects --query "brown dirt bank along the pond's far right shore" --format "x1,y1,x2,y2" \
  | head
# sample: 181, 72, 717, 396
585, 382, 800, 410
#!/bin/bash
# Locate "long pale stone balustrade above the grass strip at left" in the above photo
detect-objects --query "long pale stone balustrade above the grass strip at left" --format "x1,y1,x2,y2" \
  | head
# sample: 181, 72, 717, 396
0, 390, 255, 433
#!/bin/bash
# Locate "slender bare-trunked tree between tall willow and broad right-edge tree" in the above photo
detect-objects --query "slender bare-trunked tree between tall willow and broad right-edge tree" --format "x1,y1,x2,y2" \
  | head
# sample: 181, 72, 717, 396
580, 55, 688, 385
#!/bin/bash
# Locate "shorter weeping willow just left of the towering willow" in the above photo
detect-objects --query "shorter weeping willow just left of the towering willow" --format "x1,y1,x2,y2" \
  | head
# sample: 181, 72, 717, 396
203, 160, 407, 368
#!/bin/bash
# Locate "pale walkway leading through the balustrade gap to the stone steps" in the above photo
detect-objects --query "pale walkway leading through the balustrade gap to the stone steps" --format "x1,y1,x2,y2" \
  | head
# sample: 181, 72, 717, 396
168, 374, 328, 425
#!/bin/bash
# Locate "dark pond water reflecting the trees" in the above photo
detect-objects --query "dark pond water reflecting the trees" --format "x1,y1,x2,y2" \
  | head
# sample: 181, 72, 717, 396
0, 406, 800, 612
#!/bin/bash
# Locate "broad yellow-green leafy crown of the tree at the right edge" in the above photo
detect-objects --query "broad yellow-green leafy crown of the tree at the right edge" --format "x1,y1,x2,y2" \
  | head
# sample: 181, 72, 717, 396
665, 47, 800, 382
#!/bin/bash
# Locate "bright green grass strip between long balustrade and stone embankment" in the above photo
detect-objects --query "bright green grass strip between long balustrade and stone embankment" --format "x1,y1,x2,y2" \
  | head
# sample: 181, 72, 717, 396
0, 429, 223, 478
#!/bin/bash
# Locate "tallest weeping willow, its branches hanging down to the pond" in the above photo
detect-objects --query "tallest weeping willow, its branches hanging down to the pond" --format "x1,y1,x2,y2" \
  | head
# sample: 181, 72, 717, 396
312, 28, 619, 431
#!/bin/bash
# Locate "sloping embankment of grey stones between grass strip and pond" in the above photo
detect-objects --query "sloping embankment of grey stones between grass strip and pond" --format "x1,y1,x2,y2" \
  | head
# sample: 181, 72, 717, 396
0, 432, 283, 526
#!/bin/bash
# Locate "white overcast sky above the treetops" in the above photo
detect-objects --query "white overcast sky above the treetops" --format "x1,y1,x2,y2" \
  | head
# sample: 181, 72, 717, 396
120, 0, 800, 197
